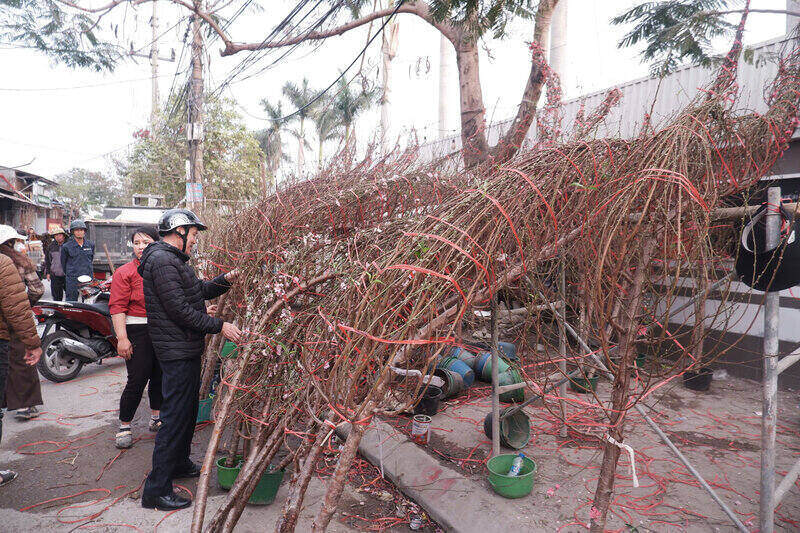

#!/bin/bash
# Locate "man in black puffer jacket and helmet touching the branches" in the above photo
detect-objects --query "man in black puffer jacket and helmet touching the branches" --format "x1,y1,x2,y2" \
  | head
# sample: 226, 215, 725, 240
139, 209, 241, 511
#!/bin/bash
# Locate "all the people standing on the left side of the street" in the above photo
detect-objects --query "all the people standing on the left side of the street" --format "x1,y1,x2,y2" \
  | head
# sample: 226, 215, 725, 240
0, 209, 242, 511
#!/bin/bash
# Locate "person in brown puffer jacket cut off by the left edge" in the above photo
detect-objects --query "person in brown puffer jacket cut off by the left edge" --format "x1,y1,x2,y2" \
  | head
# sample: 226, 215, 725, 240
0, 241, 42, 486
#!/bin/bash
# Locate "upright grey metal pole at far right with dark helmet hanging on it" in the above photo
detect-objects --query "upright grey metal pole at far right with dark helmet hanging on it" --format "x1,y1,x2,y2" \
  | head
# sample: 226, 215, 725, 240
759, 187, 781, 533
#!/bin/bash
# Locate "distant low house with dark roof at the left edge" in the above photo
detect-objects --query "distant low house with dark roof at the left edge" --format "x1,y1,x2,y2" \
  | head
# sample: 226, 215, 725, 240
0, 166, 67, 235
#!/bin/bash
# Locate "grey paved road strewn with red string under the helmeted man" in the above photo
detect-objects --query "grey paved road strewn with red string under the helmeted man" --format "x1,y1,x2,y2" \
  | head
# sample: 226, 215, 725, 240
0, 310, 354, 532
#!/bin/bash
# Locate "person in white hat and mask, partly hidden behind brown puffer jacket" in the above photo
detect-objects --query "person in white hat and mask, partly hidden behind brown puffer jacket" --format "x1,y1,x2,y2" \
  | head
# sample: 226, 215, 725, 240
0, 225, 44, 420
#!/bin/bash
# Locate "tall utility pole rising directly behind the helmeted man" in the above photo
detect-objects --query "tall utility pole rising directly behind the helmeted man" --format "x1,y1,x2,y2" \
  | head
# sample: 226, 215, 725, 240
186, 0, 204, 211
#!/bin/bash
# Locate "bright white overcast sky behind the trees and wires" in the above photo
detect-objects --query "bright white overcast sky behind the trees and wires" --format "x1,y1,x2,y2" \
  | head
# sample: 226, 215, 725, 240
0, 0, 785, 183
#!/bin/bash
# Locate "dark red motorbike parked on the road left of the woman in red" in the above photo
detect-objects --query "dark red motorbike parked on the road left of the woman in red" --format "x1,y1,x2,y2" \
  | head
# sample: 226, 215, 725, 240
33, 276, 117, 383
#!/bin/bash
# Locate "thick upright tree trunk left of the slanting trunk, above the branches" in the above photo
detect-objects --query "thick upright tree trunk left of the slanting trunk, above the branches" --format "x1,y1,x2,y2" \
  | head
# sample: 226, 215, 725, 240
455, 35, 489, 168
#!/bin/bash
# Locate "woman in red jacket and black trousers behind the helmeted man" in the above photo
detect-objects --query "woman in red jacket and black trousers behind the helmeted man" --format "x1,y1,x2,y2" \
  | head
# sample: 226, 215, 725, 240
108, 226, 163, 448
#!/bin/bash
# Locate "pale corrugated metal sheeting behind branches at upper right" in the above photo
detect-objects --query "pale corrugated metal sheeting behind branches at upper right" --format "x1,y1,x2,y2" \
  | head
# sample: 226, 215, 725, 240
420, 37, 792, 160
